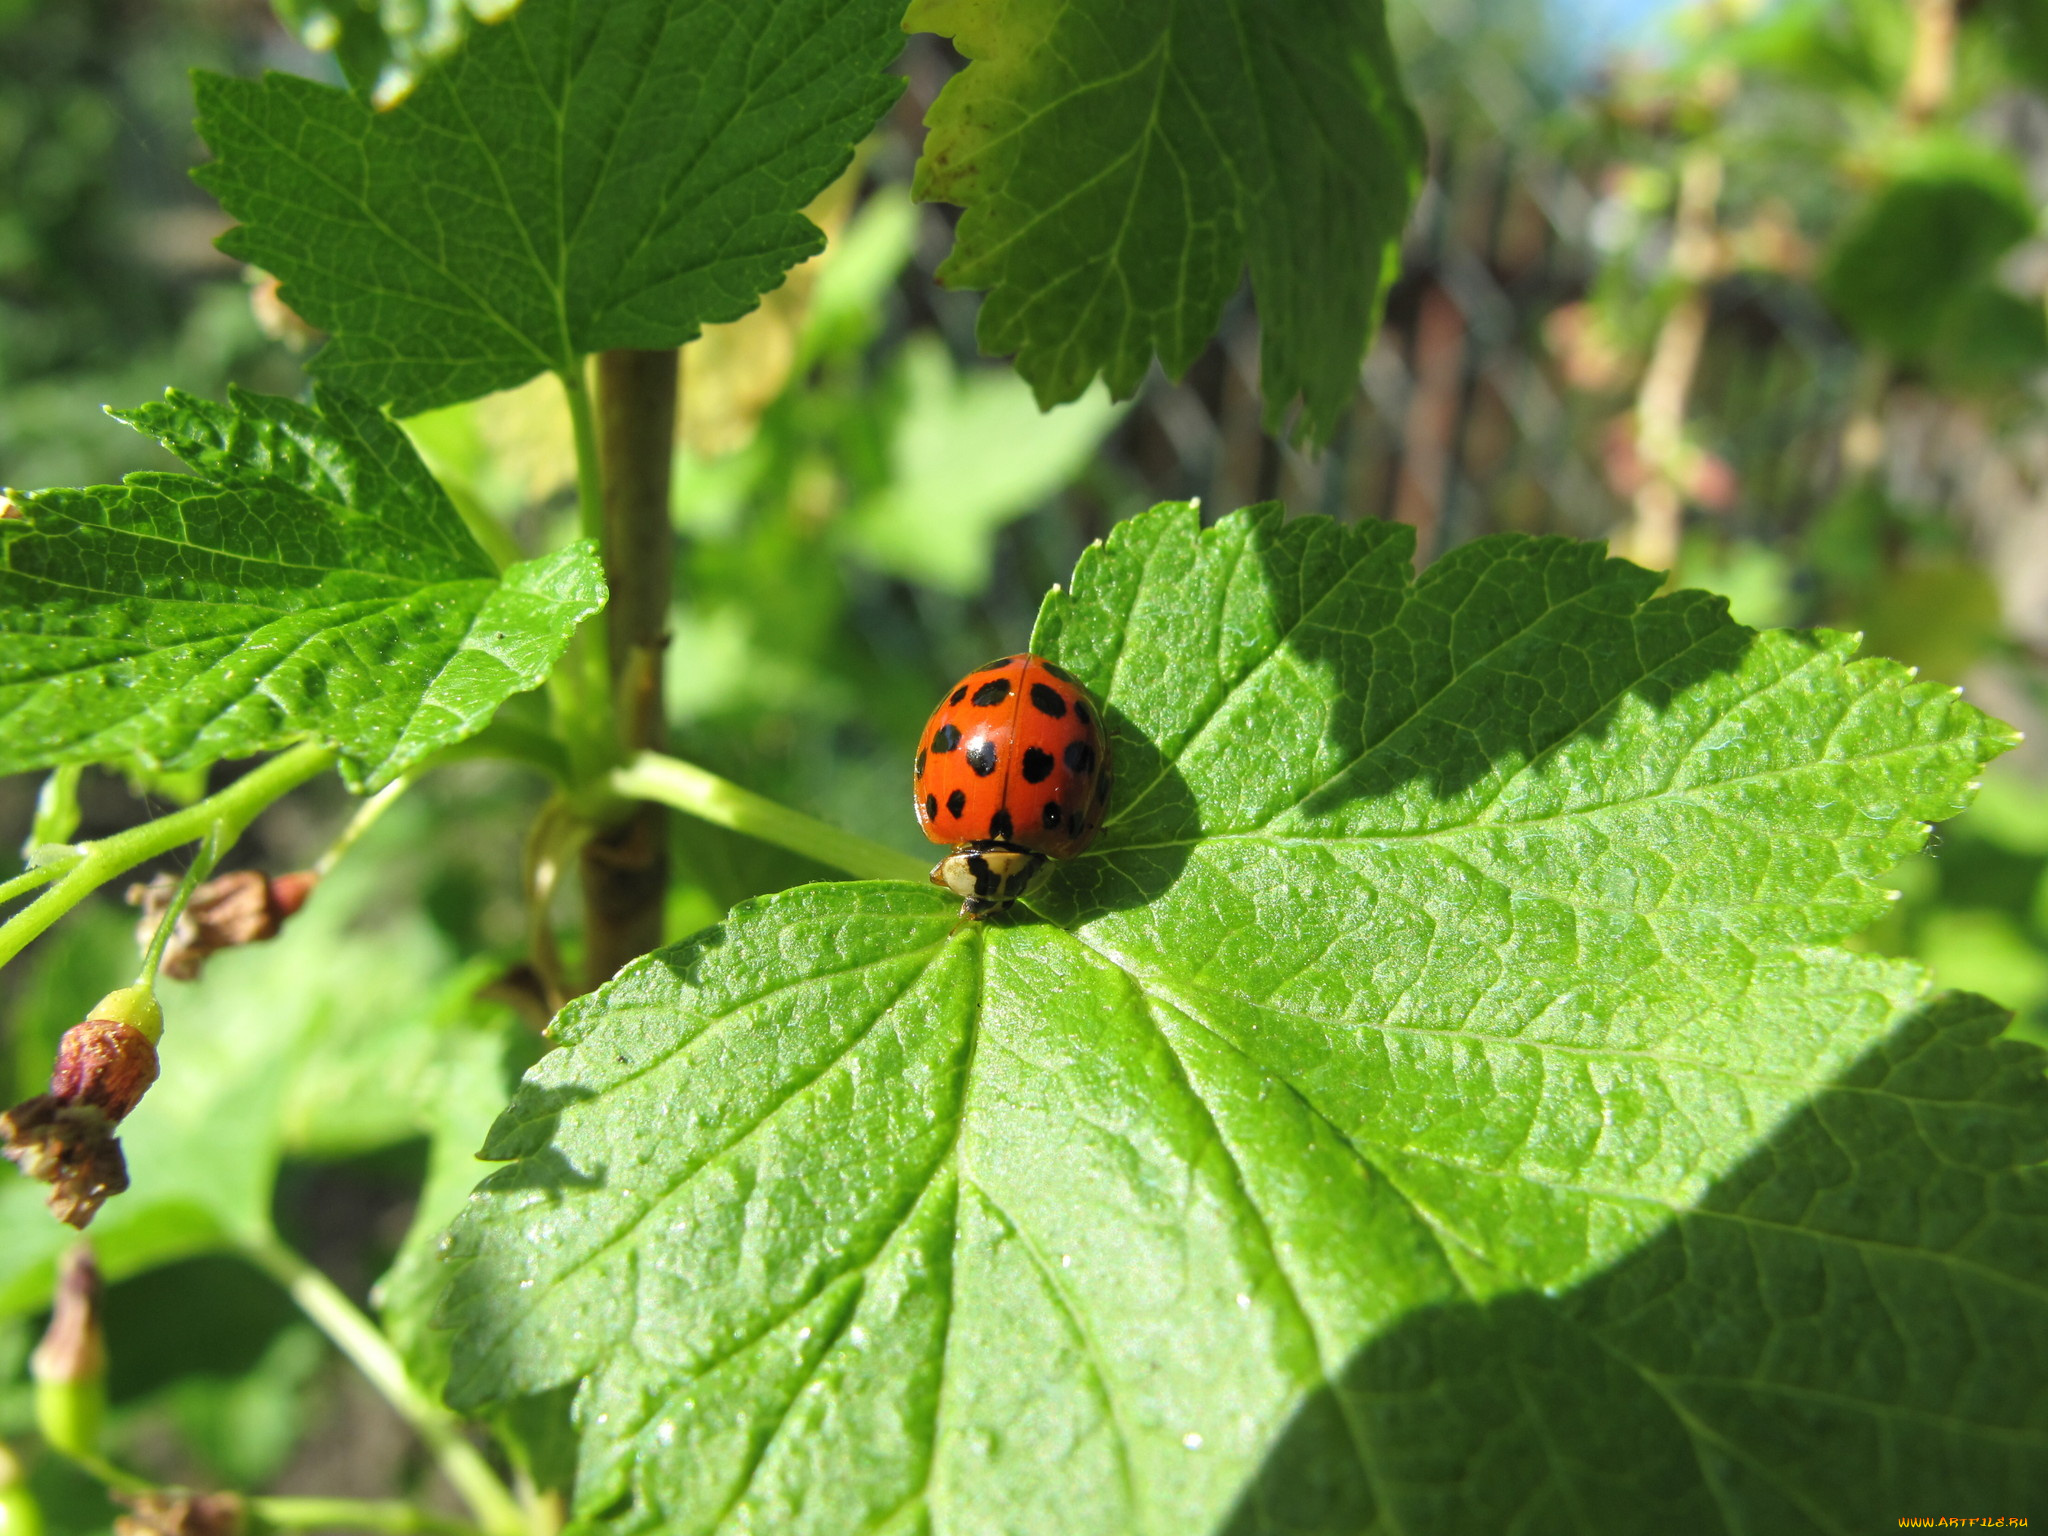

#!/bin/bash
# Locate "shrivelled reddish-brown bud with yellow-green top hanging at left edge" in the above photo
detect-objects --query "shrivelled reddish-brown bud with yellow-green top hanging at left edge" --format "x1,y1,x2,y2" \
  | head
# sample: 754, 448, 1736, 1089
0, 987, 164, 1227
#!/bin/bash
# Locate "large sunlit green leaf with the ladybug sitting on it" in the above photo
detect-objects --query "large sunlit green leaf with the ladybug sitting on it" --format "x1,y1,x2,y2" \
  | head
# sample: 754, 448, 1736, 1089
436, 506, 2048, 1536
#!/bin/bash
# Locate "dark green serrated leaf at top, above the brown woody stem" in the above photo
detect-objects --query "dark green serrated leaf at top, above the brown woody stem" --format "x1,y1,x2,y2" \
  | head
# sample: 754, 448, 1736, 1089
199, 0, 903, 416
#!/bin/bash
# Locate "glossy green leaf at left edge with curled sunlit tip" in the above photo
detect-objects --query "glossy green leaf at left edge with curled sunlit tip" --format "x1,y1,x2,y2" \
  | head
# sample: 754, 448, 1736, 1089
0, 391, 604, 788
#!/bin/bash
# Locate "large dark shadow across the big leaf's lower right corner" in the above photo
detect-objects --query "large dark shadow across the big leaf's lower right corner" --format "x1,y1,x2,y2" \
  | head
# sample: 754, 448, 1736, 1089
1217, 995, 2048, 1536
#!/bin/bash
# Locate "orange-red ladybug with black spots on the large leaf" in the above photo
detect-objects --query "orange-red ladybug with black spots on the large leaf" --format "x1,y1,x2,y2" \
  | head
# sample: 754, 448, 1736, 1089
911, 655, 1110, 920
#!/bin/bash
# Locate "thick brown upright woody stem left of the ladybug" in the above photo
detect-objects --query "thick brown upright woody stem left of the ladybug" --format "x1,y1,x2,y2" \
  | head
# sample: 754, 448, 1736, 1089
578, 348, 680, 987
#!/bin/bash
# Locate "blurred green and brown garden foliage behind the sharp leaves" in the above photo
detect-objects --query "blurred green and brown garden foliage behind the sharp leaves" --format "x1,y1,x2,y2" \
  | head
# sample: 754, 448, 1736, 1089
0, 0, 2048, 1532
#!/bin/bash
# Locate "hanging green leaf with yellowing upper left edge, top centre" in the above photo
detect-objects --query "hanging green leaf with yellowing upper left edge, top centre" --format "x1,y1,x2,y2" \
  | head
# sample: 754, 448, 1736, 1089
903, 0, 1423, 442
